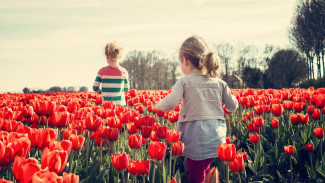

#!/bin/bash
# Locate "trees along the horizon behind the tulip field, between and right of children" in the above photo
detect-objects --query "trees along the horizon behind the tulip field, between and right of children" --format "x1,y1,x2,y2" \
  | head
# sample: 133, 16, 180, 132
121, 0, 325, 89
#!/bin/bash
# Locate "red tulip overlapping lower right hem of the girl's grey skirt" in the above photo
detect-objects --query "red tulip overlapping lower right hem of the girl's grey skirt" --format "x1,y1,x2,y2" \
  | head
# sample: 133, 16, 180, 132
217, 143, 236, 163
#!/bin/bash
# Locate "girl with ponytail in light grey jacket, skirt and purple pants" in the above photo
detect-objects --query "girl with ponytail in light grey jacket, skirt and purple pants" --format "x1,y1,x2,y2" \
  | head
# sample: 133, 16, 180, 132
155, 36, 238, 183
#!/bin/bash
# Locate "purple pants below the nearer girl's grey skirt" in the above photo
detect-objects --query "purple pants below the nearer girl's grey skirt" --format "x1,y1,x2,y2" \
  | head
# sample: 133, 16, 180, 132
186, 158, 215, 183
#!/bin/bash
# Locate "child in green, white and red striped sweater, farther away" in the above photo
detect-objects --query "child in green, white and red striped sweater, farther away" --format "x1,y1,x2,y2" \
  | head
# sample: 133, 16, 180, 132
93, 42, 129, 106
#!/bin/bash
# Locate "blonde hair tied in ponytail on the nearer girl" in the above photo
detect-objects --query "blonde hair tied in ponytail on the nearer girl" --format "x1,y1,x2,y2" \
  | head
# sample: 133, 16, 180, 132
179, 35, 220, 78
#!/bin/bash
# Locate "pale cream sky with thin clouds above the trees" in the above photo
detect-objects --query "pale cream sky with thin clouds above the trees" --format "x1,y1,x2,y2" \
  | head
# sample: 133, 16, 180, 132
0, 0, 296, 93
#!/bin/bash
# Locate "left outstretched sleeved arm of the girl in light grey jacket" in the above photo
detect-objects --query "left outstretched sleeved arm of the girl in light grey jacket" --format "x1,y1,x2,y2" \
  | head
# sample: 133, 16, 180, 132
155, 80, 184, 112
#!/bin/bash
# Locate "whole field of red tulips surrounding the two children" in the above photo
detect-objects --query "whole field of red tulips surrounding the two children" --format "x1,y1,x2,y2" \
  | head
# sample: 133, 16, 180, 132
0, 87, 325, 183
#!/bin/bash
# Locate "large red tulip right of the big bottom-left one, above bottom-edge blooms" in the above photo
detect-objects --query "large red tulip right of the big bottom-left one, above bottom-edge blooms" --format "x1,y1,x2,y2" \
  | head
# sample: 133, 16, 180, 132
41, 148, 69, 174
